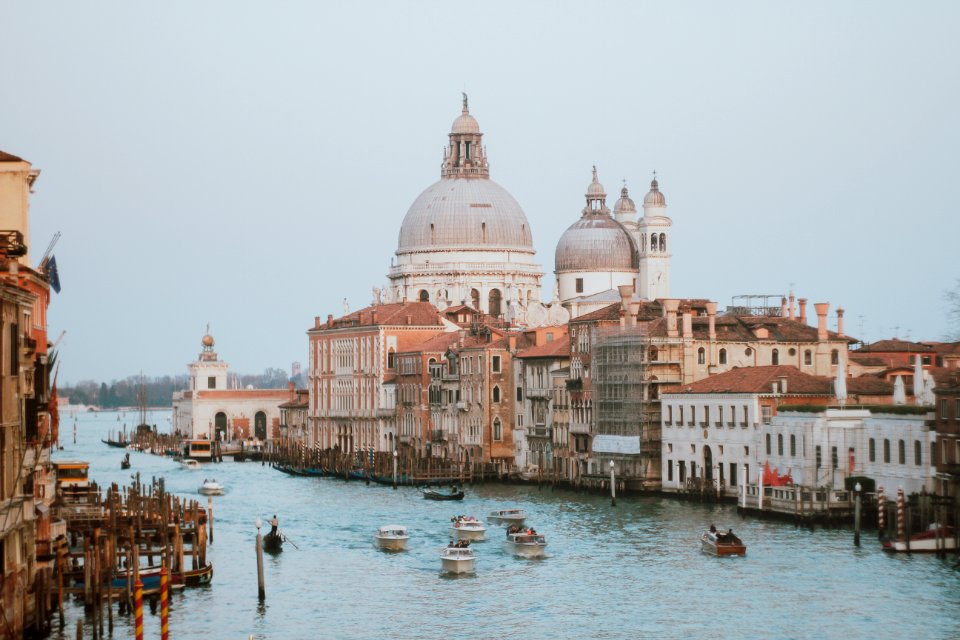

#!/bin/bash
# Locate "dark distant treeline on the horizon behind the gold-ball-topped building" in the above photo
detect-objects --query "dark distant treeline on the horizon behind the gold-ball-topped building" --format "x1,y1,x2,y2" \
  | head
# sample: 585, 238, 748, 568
57, 369, 303, 408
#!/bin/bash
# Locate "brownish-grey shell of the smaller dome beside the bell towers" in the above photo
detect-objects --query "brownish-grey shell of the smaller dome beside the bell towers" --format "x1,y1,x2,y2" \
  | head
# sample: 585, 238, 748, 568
555, 214, 640, 273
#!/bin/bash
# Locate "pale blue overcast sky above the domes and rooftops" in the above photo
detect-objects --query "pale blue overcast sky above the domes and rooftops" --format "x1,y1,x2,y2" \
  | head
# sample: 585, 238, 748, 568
0, 1, 960, 382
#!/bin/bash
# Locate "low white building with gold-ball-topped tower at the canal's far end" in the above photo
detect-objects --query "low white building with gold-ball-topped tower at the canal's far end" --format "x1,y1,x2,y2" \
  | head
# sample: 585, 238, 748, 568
172, 334, 294, 440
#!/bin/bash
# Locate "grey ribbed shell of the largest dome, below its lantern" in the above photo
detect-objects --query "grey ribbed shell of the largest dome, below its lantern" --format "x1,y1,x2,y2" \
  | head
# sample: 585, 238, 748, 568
397, 178, 534, 255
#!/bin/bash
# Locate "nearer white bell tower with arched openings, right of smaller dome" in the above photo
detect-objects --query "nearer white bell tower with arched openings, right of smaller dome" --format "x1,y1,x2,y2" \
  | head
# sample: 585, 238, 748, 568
635, 174, 673, 300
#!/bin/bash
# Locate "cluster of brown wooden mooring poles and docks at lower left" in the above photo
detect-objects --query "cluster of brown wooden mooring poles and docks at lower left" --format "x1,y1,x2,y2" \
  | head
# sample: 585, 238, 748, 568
57, 474, 213, 638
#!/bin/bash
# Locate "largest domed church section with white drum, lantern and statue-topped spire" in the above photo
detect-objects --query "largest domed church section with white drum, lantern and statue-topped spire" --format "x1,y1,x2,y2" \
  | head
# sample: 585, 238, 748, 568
386, 95, 547, 325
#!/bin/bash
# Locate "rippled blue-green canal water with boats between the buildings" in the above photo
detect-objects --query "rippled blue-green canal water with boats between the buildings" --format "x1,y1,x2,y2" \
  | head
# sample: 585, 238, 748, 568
54, 412, 960, 639
